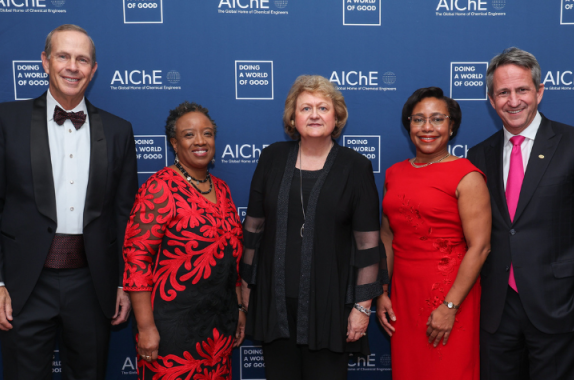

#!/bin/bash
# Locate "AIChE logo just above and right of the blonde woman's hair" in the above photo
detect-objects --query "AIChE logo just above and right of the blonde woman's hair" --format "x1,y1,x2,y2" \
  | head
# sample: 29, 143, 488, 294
329, 70, 397, 91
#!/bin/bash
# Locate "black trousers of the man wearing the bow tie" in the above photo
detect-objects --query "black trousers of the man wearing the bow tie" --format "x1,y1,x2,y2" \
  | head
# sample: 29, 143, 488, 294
0, 267, 110, 380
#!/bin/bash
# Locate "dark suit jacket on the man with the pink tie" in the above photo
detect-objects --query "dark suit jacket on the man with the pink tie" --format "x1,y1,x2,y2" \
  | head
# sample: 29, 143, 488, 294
468, 116, 574, 334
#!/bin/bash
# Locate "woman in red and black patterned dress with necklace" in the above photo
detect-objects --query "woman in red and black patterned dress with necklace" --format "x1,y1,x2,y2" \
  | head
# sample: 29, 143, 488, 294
124, 102, 245, 380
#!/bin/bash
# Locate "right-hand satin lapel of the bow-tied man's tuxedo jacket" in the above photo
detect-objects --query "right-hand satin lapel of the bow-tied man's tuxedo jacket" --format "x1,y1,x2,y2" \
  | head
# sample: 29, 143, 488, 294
84, 99, 108, 228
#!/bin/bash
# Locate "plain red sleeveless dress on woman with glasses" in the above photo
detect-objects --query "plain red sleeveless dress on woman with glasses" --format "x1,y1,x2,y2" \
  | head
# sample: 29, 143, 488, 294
383, 159, 484, 380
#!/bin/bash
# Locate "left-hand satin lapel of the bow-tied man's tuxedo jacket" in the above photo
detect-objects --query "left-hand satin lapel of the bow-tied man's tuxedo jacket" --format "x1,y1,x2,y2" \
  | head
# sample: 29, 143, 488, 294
30, 93, 57, 222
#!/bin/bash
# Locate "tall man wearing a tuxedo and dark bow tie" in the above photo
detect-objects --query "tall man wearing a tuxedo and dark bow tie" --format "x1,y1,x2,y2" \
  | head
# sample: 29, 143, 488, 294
0, 25, 137, 380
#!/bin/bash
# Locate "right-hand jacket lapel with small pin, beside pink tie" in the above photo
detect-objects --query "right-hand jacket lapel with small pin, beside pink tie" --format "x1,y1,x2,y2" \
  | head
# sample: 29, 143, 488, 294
514, 116, 562, 221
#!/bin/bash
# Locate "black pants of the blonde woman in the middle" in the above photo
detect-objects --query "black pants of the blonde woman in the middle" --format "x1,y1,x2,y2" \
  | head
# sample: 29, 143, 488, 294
263, 298, 349, 380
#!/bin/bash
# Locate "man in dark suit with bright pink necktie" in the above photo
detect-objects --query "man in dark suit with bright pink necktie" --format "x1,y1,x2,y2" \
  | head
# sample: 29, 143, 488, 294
468, 48, 574, 380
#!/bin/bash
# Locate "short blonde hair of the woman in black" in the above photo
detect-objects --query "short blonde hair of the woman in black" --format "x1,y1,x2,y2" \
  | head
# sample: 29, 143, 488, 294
283, 75, 349, 140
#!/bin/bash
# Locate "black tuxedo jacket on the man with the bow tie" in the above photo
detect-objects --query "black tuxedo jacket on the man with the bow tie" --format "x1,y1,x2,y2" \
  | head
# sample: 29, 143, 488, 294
0, 93, 137, 317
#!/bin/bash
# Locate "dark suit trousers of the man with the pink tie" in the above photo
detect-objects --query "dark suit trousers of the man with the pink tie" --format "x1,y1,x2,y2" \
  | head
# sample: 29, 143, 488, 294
480, 287, 574, 380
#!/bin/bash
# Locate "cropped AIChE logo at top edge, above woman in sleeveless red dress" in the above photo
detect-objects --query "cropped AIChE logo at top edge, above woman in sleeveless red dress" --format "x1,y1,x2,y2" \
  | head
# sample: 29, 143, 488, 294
435, 0, 506, 17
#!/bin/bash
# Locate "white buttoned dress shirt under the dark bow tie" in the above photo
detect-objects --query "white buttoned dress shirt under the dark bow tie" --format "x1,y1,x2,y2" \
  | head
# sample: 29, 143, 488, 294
46, 90, 90, 235
